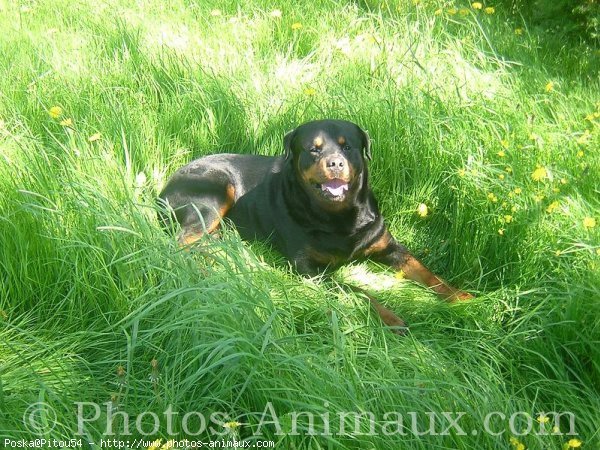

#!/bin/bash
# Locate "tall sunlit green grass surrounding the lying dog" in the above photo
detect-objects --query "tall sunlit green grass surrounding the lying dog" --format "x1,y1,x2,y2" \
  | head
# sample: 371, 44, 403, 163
0, 0, 600, 449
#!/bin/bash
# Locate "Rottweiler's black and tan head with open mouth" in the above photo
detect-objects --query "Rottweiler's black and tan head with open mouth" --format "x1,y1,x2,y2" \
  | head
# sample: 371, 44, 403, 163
284, 120, 371, 210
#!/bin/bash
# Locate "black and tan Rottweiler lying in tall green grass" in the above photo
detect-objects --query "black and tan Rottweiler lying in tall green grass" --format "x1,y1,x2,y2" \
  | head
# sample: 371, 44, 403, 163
160, 120, 471, 333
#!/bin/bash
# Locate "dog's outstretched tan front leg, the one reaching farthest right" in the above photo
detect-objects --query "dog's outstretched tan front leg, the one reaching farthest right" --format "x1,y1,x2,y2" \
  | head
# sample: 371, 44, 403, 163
366, 231, 473, 302
